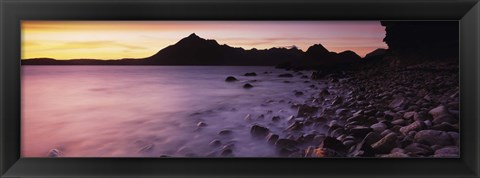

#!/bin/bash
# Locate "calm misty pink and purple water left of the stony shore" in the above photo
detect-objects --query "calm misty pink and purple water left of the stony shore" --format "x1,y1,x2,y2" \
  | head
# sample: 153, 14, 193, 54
22, 66, 322, 157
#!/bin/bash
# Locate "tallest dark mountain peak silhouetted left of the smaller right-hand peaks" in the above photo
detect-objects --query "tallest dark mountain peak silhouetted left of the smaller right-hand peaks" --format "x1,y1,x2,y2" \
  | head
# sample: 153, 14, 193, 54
145, 33, 303, 66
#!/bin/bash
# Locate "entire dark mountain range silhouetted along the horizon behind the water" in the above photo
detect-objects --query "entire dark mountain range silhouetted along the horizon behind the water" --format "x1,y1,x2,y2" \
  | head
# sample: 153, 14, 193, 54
22, 33, 384, 68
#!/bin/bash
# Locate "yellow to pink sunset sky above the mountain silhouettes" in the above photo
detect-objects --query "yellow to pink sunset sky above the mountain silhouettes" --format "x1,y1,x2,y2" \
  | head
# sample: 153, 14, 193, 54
21, 21, 387, 59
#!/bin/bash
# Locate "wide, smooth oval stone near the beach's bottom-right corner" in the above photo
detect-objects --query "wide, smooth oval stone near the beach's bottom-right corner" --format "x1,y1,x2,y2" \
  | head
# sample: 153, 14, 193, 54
414, 130, 453, 146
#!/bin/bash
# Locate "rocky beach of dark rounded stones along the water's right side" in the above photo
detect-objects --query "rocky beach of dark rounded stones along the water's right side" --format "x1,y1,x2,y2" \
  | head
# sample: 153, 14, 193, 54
222, 60, 459, 157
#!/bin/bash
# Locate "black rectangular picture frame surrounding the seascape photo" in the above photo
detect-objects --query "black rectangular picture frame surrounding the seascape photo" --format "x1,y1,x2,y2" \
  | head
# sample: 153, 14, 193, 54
0, 0, 480, 178
